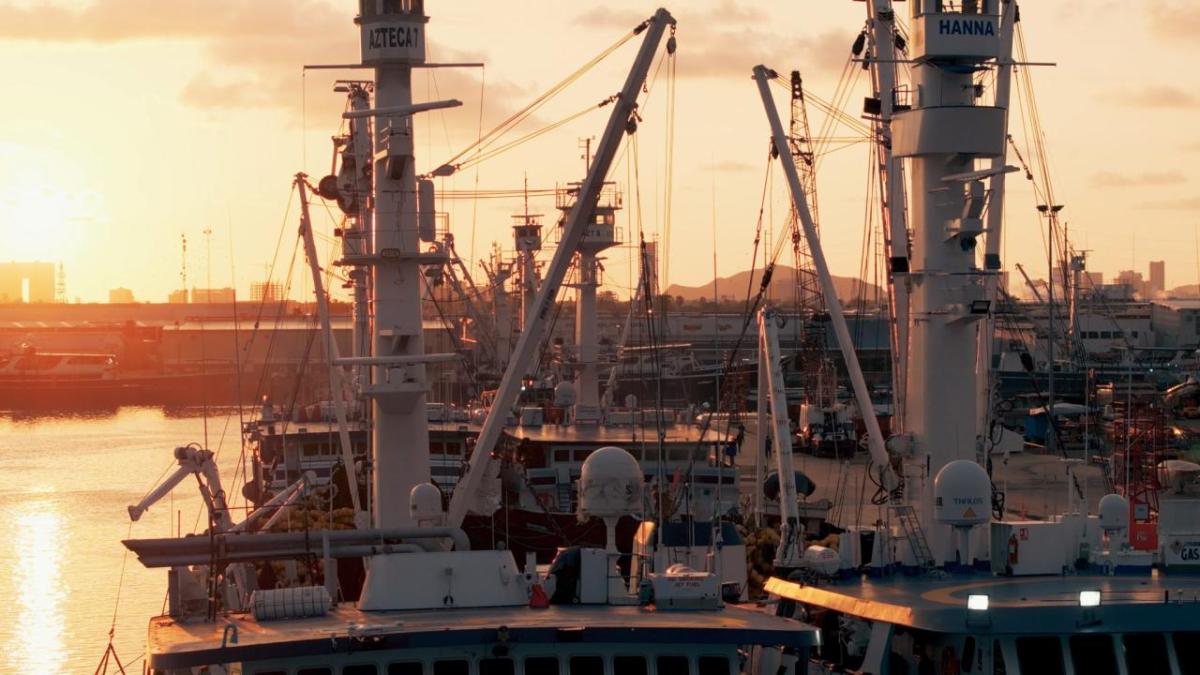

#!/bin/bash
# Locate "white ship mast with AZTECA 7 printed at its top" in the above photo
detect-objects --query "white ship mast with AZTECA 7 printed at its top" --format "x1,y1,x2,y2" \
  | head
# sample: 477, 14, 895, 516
356, 0, 461, 535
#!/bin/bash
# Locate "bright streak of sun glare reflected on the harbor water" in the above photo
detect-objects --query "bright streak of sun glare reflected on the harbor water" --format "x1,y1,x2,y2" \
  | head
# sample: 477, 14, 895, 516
8, 496, 68, 673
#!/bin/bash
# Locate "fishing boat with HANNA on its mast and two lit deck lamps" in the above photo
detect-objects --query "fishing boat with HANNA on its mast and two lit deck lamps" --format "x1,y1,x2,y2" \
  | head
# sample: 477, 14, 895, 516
754, 0, 1200, 675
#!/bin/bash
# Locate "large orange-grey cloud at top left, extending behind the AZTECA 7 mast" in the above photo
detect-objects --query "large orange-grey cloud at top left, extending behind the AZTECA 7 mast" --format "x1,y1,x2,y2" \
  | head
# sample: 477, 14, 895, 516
0, 0, 529, 127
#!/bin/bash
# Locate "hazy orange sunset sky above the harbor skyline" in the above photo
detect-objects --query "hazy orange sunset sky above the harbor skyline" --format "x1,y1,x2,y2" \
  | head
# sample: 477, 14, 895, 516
0, 0, 1200, 301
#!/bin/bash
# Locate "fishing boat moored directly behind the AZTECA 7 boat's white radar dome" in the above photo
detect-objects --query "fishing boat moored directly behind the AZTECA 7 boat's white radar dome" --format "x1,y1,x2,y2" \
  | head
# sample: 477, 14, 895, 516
242, 416, 740, 562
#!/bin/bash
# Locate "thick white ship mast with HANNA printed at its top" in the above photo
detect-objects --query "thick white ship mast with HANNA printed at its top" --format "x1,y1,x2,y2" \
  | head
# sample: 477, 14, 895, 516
897, 0, 1013, 565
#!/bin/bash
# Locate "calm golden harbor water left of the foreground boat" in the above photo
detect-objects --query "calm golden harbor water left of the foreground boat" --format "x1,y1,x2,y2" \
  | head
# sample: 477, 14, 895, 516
0, 407, 247, 673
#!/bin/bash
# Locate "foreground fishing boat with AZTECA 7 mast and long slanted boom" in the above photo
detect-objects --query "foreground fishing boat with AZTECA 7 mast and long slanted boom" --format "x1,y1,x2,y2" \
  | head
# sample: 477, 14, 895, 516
117, 0, 818, 675
